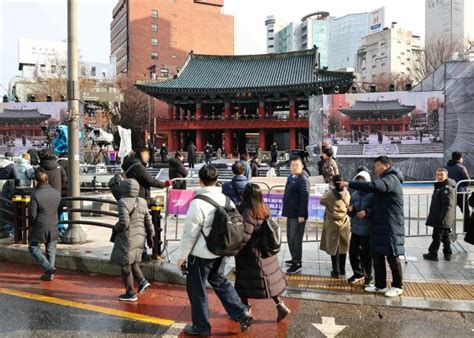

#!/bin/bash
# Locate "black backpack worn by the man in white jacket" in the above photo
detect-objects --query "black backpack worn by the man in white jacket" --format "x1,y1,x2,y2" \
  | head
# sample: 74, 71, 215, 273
194, 195, 245, 256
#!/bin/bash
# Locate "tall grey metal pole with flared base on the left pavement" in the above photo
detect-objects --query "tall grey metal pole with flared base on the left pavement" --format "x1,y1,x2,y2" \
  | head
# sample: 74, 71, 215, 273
62, 0, 87, 244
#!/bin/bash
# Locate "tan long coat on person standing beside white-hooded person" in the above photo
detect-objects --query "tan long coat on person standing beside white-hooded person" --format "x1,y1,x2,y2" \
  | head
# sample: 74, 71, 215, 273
320, 189, 351, 256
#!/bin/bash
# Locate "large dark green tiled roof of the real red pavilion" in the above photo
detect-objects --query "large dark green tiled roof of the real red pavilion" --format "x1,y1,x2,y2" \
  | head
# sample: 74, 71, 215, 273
136, 50, 353, 95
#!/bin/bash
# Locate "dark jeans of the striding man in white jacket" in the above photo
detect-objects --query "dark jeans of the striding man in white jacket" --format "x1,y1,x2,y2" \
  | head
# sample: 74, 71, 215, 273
186, 255, 247, 332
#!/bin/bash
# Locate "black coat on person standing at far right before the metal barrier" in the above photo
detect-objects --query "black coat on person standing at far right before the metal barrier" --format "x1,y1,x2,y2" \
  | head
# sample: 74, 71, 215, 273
426, 178, 456, 229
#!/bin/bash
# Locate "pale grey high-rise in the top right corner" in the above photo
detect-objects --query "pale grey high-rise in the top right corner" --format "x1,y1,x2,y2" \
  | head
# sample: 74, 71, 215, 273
425, 0, 474, 44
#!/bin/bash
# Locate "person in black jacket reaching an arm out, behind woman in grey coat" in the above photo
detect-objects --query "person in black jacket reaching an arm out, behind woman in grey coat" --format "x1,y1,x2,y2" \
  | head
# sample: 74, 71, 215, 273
122, 148, 171, 204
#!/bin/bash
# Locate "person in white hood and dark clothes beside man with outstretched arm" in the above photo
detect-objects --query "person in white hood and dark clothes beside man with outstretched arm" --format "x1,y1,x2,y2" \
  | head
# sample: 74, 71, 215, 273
348, 170, 374, 287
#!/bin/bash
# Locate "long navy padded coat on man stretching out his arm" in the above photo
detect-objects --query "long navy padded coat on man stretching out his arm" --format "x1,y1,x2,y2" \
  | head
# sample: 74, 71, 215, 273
349, 167, 405, 256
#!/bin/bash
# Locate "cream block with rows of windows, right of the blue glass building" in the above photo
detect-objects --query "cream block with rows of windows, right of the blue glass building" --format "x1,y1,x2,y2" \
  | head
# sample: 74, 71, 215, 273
357, 24, 421, 82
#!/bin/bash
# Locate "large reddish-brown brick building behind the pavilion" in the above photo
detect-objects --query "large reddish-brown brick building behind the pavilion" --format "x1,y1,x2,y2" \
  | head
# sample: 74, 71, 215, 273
110, 0, 234, 78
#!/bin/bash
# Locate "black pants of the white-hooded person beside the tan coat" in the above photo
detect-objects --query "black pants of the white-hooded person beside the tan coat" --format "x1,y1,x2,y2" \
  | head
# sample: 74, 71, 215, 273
349, 234, 372, 281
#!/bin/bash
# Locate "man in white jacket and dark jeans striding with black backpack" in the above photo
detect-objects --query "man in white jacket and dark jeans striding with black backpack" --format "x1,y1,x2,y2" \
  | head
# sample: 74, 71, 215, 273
177, 165, 253, 336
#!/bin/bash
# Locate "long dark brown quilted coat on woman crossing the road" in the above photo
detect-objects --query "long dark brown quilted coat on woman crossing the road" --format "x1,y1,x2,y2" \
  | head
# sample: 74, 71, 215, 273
235, 209, 286, 299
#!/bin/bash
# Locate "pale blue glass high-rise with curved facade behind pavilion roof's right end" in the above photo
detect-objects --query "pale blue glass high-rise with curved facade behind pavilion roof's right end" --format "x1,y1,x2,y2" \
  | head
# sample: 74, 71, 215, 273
265, 8, 384, 69
